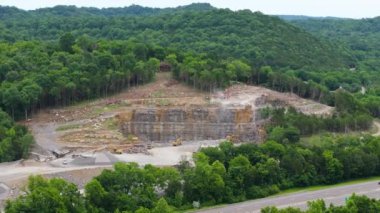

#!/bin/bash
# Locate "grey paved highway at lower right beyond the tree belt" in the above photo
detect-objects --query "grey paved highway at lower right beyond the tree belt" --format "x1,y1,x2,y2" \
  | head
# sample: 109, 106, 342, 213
198, 181, 380, 213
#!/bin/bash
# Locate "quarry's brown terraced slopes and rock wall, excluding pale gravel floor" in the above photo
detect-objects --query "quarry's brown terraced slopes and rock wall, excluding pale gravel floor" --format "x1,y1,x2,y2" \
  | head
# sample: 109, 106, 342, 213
27, 73, 333, 154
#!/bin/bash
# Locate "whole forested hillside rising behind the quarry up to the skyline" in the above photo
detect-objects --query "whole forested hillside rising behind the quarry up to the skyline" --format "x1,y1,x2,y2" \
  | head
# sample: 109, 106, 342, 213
0, 4, 380, 163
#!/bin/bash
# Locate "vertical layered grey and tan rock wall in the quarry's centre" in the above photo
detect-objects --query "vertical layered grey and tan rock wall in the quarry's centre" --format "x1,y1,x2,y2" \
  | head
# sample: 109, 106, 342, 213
117, 106, 259, 142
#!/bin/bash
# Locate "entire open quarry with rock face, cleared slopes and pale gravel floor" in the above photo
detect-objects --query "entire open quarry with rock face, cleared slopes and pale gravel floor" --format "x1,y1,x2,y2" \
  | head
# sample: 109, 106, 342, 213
0, 73, 333, 209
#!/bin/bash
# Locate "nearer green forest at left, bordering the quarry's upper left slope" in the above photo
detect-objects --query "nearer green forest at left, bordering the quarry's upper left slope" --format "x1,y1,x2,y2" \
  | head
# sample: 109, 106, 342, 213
0, 37, 163, 118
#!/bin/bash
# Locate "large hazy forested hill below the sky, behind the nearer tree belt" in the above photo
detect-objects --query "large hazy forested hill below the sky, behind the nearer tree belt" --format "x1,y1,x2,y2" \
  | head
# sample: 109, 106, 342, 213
0, 4, 355, 70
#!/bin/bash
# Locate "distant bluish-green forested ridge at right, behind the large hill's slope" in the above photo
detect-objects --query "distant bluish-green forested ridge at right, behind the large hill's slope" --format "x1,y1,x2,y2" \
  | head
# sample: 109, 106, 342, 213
282, 17, 380, 70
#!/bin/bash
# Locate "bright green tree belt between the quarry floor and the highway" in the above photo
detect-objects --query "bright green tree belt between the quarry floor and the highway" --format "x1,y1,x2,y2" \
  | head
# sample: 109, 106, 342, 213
6, 135, 380, 213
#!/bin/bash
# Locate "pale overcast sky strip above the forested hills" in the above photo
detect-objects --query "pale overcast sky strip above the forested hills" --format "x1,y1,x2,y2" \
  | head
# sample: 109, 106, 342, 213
0, 0, 380, 18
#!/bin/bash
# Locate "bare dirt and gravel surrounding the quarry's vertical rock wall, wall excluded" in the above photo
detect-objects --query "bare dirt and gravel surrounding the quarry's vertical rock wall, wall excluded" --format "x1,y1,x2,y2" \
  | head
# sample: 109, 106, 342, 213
0, 73, 336, 209
